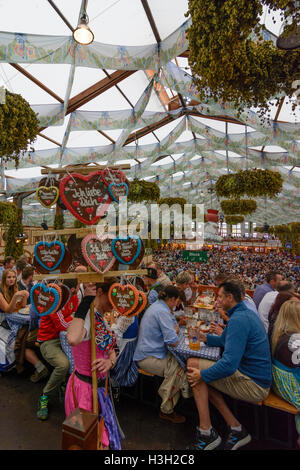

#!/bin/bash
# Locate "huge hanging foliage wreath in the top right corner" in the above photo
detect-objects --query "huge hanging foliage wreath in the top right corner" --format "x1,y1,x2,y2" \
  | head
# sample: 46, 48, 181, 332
187, 0, 300, 115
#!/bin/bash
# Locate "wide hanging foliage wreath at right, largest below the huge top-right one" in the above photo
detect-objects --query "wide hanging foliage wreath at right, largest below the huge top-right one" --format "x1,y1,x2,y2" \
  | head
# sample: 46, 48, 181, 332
215, 168, 283, 198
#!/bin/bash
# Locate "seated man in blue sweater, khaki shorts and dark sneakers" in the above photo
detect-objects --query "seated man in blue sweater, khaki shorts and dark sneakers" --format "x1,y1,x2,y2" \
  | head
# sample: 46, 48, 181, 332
187, 282, 272, 450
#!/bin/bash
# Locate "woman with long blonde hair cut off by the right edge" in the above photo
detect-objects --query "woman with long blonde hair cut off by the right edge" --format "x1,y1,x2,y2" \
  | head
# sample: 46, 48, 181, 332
271, 300, 300, 446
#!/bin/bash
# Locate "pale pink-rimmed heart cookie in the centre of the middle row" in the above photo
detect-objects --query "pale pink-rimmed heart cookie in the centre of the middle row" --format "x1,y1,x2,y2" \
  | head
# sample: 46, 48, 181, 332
81, 234, 116, 274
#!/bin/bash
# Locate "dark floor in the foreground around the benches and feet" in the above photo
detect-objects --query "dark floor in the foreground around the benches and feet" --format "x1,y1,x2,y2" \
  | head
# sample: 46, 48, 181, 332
0, 371, 298, 450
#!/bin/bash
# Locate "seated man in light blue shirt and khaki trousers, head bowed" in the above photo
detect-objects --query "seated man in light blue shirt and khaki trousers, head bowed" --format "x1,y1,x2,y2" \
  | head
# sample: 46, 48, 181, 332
133, 286, 190, 423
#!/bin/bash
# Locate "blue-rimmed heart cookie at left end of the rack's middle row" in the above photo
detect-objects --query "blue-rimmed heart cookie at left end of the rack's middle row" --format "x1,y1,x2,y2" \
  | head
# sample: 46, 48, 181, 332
34, 241, 65, 271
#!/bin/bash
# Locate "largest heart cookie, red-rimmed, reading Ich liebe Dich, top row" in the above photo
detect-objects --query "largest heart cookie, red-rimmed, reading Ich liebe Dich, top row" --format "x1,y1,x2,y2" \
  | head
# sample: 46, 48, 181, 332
59, 170, 111, 225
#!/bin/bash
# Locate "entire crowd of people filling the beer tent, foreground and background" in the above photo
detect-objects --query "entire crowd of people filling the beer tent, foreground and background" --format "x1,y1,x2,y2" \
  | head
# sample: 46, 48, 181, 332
0, 250, 300, 450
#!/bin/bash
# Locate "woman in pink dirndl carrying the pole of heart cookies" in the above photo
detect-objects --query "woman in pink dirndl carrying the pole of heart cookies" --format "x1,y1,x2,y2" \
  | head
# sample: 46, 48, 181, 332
65, 280, 124, 450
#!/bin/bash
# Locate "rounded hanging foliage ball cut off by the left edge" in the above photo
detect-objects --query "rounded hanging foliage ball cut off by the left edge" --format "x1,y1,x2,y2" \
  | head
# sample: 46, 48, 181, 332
0, 90, 40, 168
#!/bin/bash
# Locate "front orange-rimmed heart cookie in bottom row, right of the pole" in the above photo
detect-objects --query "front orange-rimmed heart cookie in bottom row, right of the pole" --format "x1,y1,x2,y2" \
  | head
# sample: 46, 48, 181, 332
108, 282, 139, 316
